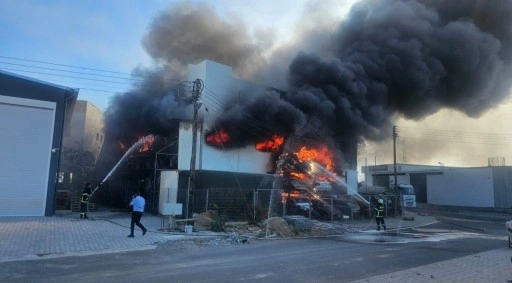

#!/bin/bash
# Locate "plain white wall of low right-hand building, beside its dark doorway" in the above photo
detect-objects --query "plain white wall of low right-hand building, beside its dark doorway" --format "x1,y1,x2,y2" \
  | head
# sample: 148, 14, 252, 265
427, 168, 494, 207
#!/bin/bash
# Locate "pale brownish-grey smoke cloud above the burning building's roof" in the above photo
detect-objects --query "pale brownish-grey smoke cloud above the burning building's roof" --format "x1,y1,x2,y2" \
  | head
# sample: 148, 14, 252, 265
142, 2, 272, 80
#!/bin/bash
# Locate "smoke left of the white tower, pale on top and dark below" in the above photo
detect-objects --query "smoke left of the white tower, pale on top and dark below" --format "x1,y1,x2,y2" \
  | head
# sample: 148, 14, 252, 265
105, 2, 264, 151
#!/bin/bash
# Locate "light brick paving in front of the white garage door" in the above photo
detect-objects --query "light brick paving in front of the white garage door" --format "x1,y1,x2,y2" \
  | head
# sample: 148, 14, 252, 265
0, 211, 196, 262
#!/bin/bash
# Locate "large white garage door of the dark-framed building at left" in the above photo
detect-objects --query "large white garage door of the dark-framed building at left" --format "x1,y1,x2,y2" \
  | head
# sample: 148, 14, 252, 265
0, 95, 55, 216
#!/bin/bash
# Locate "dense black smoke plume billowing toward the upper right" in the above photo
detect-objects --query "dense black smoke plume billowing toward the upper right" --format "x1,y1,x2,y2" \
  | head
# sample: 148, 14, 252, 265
208, 0, 512, 169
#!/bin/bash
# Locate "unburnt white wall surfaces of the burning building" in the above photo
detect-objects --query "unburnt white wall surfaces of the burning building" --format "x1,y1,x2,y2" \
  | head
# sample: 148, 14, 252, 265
182, 61, 271, 174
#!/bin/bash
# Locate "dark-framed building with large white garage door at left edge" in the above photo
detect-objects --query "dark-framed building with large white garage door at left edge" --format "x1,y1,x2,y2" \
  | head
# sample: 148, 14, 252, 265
0, 70, 78, 216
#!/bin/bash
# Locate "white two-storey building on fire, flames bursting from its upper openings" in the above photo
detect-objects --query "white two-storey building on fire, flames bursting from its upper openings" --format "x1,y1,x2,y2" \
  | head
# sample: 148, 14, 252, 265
98, 60, 357, 220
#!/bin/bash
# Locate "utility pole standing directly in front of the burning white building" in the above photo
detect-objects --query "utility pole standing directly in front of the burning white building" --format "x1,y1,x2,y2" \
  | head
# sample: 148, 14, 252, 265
186, 79, 204, 218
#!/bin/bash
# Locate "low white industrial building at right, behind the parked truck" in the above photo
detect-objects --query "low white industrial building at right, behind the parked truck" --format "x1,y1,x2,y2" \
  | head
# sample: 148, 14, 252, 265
360, 164, 512, 209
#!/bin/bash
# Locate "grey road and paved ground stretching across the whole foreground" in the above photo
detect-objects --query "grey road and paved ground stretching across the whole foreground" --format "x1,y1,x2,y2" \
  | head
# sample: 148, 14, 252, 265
0, 207, 512, 283
